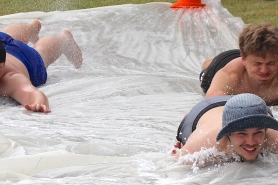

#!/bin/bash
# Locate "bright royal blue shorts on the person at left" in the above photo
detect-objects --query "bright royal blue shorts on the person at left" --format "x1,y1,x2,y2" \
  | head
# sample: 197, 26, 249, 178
0, 32, 47, 87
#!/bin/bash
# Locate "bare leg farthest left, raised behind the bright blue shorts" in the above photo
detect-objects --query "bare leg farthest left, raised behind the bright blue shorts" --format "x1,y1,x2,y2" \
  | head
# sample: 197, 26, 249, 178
3, 19, 41, 44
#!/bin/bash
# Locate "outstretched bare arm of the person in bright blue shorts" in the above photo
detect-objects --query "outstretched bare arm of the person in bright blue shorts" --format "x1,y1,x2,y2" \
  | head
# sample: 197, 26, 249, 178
2, 73, 51, 113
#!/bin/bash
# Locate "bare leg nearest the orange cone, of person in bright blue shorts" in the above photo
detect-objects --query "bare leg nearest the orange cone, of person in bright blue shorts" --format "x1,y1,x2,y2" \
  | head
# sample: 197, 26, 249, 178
34, 30, 83, 68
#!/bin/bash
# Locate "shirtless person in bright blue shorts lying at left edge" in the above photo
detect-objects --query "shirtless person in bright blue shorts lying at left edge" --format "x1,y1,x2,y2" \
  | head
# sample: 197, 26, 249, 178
0, 20, 83, 113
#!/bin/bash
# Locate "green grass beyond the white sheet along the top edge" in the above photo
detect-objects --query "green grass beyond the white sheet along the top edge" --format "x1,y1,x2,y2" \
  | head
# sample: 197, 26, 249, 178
0, 0, 278, 27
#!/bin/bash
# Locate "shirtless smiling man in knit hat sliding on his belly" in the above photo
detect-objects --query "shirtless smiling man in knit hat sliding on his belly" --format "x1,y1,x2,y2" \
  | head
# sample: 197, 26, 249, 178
172, 93, 278, 165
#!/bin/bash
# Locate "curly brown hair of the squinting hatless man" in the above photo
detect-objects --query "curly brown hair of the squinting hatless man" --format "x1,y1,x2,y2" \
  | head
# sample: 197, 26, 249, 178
239, 22, 278, 58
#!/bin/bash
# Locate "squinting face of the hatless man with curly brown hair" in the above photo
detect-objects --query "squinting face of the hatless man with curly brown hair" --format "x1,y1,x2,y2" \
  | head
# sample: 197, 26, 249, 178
242, 54, 278, 85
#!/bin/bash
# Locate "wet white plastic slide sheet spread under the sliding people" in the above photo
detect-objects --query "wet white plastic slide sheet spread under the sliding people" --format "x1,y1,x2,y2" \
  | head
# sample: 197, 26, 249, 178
0, 0, 278, 185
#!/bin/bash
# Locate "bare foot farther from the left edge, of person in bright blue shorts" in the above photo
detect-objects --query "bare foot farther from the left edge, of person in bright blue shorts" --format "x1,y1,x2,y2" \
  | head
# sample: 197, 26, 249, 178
61, 30, 83, 68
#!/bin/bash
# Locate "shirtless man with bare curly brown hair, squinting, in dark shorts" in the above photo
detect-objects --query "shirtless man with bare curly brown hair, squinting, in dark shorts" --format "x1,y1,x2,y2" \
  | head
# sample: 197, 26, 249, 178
200, 23, 278, 105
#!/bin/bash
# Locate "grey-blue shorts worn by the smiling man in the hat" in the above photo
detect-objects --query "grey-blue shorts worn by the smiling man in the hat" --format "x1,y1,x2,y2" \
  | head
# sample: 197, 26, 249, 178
176, 95, 233, 145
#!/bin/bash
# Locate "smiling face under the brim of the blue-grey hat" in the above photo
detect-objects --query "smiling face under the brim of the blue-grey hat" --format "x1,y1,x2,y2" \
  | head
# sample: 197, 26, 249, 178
229, 128, 266, 162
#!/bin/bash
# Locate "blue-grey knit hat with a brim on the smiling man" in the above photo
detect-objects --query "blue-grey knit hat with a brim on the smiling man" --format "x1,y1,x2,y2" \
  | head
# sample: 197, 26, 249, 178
216, 93, 278, 141
